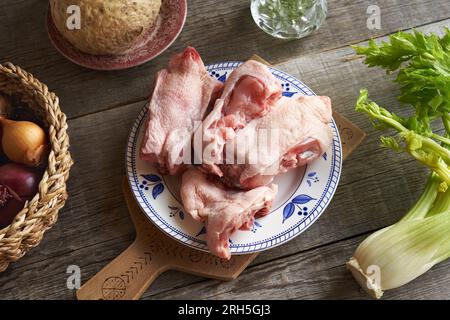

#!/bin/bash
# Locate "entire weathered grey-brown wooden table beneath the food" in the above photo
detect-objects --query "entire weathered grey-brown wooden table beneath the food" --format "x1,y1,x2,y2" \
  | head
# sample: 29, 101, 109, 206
0, 0, 450, 299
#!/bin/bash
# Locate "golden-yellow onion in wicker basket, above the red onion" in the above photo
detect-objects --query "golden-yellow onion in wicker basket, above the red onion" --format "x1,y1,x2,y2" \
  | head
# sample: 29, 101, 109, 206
0, 117, 48, 167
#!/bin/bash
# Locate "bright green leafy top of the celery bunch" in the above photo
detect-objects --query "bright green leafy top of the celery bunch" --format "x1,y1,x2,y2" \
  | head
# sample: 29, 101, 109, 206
353, 28, 450, 136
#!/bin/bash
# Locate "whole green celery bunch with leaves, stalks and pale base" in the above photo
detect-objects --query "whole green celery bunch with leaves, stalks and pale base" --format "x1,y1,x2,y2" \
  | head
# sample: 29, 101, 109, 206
347, 28, 450, 298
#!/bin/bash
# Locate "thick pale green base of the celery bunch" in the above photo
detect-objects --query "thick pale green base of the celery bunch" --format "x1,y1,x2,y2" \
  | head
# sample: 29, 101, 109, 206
347, 210, 450, 298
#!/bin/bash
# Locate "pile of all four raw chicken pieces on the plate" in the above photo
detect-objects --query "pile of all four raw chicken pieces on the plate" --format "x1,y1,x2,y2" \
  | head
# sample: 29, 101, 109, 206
140, 47, 332, 259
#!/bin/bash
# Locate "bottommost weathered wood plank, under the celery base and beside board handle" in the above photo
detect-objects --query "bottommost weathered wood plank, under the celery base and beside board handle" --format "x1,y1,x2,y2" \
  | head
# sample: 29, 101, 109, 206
146, 237, 450, 300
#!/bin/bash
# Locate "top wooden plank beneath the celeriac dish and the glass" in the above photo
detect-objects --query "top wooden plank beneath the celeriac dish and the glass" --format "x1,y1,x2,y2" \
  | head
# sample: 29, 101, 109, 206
0, 0, 450, 118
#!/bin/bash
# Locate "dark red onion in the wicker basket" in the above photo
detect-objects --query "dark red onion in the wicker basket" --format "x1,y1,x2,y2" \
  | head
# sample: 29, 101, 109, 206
0, 163, 41, 229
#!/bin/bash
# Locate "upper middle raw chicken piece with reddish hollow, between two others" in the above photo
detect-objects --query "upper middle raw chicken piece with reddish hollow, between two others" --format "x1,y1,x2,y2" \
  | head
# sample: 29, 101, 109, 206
196, 60, 282, 170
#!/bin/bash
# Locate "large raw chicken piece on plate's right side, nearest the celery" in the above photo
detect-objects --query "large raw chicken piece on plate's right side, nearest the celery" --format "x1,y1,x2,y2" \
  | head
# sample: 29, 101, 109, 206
220, 96, 333, 189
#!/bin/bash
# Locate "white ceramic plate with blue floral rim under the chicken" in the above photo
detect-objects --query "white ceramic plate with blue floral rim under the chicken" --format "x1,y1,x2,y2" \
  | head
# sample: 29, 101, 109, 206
126, 62, 342, 254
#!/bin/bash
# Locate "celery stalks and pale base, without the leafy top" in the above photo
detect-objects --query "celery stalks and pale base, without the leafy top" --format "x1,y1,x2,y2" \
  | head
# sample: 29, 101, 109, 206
347, 90, 450, 298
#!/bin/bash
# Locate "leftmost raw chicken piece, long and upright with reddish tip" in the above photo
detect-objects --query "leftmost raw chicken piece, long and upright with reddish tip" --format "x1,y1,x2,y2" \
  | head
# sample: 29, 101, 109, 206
140, 47, 223, 174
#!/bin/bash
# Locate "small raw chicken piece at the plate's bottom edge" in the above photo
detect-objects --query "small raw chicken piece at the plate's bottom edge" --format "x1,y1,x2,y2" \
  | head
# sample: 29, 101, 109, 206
180, 168, 278, 259
